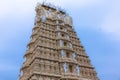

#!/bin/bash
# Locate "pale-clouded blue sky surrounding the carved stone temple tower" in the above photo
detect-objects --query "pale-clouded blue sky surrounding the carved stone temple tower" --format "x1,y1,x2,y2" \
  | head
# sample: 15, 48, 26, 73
0, 0, 120, 80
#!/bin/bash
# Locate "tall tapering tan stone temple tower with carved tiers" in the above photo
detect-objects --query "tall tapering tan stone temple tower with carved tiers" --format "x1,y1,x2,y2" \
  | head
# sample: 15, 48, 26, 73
19, 3, 99, 80
